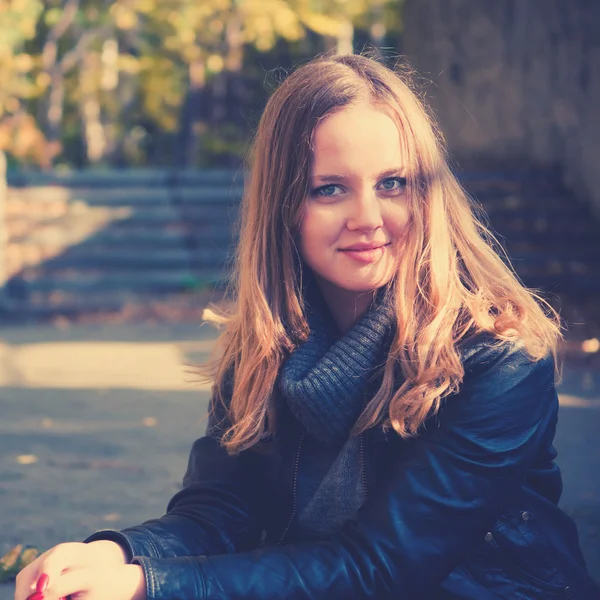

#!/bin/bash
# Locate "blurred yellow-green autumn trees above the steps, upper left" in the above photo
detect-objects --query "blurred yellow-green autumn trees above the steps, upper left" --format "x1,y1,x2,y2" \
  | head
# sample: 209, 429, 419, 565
0, 0, 401, 166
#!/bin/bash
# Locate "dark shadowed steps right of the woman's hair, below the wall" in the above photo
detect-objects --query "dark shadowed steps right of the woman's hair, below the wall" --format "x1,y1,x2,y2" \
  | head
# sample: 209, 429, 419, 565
461, 171, 600, 297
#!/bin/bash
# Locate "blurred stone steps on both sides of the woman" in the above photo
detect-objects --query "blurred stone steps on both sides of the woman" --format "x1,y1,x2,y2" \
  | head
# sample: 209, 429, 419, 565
3, 166, 600, 330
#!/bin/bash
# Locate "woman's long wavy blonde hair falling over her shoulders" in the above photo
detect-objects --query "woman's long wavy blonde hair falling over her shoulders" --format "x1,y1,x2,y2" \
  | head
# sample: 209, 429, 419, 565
201, 55, 561, 453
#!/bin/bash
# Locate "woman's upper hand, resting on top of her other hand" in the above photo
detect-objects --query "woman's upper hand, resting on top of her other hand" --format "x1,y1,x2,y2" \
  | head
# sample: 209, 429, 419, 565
15, 540, 142, 600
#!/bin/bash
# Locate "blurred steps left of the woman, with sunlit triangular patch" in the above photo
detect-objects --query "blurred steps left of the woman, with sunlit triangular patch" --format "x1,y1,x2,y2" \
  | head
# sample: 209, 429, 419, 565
4, 171, 243, 318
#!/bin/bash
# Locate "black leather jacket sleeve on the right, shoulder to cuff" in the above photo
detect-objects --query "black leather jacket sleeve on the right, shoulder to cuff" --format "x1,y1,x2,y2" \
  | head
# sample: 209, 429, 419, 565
133, 344, 557, 600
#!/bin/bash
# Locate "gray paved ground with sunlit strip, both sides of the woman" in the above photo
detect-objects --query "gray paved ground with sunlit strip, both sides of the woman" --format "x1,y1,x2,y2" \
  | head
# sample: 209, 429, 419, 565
0, 324, 600, 600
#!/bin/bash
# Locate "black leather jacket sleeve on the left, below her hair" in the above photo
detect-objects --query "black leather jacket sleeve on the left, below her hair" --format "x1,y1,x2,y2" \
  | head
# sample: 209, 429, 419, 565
84, 380, 262, 562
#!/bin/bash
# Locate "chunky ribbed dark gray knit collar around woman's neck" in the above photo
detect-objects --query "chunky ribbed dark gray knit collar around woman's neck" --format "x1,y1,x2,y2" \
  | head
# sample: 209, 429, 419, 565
280, 284, 395, 445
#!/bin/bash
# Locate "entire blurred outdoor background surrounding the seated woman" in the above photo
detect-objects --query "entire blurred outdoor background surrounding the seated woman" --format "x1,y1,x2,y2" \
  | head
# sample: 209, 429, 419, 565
0, 0, 600, 600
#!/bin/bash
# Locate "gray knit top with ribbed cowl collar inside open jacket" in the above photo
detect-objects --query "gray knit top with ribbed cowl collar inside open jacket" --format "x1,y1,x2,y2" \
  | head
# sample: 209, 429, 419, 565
280, 284, 395, 540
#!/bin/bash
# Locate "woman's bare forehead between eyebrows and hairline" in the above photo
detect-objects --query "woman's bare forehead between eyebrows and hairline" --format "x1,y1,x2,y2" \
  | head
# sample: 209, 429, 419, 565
311, 104, 403, 176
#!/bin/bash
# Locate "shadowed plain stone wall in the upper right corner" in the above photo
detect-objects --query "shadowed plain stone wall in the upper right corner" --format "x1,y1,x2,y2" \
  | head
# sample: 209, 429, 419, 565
403, 0, 600, 216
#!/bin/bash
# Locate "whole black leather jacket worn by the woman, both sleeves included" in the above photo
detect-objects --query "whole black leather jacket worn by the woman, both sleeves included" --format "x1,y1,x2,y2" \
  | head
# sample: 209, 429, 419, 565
86, 341, 600, 600
